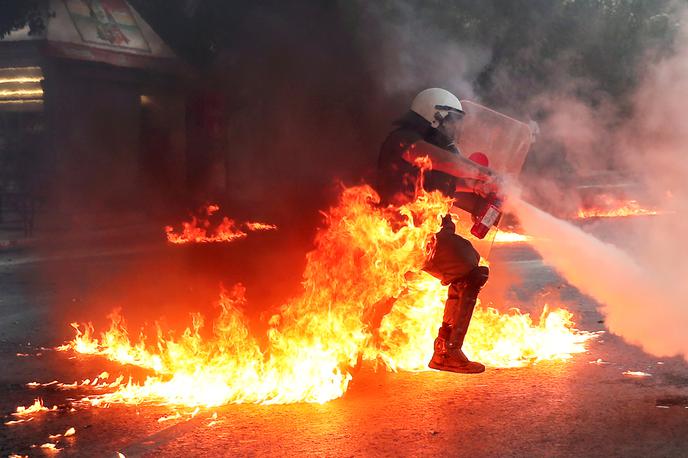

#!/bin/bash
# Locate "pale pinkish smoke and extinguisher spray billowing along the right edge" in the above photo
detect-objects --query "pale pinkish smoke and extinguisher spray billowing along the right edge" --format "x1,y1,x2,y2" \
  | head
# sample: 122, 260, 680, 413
502, 5, 688, 359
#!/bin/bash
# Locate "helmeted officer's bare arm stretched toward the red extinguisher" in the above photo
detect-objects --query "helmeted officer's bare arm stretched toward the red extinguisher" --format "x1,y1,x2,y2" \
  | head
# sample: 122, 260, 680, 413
402, 140, 495, 181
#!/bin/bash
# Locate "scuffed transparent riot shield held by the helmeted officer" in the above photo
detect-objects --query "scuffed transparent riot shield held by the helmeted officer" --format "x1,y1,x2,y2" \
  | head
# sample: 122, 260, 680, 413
452, 100, 531, 260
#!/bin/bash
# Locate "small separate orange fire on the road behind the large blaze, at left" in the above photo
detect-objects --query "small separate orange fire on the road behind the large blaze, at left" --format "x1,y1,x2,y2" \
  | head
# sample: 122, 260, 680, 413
165, 204, 277, 244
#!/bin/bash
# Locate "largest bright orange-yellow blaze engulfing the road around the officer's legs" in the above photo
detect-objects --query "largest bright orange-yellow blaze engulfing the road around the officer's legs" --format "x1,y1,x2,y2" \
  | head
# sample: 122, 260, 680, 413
60, 186, 591, 406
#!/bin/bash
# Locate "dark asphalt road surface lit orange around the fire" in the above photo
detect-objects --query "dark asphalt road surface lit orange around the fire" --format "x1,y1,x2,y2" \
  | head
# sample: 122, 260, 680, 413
0, 216, 688, 457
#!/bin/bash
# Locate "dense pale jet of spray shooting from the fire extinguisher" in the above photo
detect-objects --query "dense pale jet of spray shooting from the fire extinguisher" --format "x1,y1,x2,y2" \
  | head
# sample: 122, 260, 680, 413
509, 198, 688, 359
